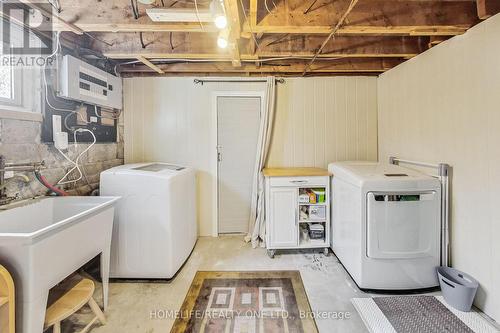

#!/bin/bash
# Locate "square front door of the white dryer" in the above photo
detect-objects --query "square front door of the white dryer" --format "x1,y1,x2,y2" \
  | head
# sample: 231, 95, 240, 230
366, 191, 441, 259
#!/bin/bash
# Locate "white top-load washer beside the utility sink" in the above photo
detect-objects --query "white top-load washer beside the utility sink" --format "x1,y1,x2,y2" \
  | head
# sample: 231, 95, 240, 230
100, 163, 197, 279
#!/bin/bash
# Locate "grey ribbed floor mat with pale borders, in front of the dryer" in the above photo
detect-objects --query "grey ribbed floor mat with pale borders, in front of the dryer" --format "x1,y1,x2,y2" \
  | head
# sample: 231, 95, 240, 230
351, 296, 499, 333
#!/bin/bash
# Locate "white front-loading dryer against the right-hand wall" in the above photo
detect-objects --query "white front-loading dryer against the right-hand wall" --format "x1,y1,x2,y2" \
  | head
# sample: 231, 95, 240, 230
328, 162, 441, 290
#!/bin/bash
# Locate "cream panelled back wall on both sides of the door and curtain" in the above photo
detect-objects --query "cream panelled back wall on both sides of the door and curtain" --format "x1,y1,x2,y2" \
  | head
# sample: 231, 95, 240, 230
124, 77, 377, 236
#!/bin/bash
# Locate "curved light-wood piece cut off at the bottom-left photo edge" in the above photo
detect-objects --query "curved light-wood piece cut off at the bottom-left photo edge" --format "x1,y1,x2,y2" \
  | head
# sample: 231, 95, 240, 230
0, 265, 16, 333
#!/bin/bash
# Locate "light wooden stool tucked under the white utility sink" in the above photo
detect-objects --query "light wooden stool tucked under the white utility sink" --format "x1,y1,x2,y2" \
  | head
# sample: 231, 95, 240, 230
45, 279, 106, 333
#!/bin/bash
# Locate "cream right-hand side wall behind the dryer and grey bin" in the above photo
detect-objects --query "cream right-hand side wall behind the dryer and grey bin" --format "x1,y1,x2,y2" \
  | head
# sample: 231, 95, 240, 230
378, 15, 500, 321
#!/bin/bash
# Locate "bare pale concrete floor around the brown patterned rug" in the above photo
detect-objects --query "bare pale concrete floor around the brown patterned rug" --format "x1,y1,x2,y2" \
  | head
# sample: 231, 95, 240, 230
63, 236, 378, 333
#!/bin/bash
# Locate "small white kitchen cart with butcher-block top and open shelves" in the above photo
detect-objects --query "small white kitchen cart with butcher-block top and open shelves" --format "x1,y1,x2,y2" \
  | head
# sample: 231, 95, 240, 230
264, 168, 330, 257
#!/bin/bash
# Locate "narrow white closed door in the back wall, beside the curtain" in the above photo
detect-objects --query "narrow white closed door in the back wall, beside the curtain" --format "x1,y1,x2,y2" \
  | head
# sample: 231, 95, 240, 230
217, 96, 261, 233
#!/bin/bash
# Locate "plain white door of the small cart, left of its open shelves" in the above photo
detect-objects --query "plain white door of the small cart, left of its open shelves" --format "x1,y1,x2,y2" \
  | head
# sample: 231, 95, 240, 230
268, 187, 299, 248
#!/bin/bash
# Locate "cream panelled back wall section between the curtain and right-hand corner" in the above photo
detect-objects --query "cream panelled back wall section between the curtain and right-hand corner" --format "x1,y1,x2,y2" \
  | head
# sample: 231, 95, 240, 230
267, 77, 377, 167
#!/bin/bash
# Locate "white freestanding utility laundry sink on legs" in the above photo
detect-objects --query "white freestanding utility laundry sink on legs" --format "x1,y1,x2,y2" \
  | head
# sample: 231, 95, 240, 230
0, 197, 119, 333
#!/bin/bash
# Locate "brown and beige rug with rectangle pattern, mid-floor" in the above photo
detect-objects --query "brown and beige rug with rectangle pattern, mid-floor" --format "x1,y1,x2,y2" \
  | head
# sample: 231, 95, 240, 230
171, 271, 318, 333
